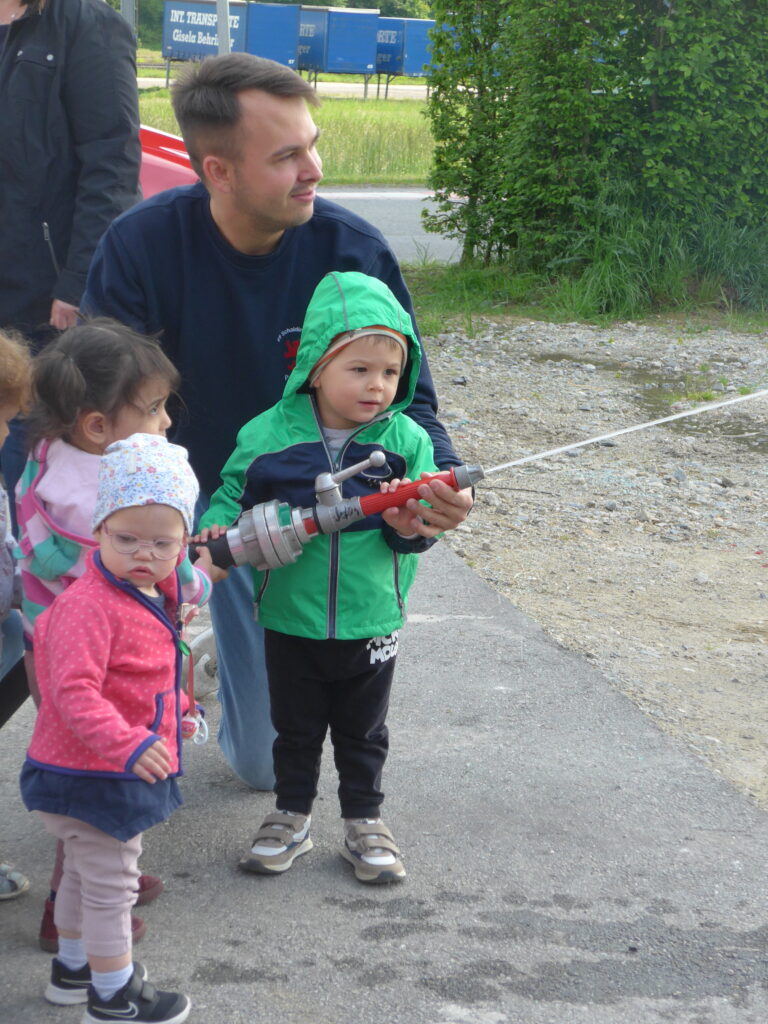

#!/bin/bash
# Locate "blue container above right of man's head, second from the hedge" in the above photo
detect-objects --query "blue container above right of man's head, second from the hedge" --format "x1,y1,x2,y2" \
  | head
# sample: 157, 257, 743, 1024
299, 7, 379, 75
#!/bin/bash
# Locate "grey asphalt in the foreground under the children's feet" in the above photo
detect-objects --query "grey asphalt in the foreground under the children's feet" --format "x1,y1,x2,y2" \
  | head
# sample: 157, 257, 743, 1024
0, 545, 768, 1024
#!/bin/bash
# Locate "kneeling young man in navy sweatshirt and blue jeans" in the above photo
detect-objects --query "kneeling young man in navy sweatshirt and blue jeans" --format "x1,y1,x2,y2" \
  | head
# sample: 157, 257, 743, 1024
82, 53, 472, 790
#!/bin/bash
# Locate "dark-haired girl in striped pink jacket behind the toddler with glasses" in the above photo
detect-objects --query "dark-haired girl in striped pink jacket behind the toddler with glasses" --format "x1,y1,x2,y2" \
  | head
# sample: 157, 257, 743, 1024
16, 318, 211, 950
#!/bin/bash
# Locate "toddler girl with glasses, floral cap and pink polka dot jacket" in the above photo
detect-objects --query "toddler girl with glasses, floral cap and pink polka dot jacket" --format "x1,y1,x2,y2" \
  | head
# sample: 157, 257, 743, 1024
22, 434, 210, 1024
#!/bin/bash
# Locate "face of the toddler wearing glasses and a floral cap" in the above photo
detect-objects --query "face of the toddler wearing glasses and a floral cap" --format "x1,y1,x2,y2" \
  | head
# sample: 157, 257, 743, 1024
97, 505, 186, 597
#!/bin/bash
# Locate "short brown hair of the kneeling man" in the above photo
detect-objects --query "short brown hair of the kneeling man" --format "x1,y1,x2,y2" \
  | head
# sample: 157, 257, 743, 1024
171, 53, 319, 178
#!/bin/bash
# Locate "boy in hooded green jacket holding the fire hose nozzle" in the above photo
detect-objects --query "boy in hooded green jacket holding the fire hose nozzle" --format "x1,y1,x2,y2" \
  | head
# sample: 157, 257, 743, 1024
201, 272, 436, 883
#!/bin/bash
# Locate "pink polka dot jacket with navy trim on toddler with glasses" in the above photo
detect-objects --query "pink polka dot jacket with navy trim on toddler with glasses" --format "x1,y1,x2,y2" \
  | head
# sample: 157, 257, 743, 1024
27, 553, 210, 785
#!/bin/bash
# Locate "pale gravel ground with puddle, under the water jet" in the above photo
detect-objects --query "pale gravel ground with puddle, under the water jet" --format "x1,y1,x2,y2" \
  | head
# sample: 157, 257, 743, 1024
426, 321, 768, 807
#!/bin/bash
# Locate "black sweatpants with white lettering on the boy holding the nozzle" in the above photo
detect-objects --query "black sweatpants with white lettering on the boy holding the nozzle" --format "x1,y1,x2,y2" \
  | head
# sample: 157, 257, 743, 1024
264, 630, 397, 818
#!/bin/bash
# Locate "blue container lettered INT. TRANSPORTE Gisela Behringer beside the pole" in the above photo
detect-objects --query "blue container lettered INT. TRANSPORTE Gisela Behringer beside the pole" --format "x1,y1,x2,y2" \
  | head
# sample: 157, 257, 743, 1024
163, 0, 247, 60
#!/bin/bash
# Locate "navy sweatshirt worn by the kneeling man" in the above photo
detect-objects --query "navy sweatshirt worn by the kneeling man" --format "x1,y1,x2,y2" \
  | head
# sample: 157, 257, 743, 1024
81, 184, 460, 503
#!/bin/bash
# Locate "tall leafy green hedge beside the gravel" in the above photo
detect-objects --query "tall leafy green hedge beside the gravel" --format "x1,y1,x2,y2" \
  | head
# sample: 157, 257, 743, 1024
428, 0, 768, 307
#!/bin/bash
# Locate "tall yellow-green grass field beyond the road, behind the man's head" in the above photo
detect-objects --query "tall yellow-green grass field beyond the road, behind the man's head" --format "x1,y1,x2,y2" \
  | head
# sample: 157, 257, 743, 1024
139, 88, 432, 185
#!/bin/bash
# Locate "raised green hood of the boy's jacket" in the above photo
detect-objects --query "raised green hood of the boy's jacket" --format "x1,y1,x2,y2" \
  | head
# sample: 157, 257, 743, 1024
284, 270, 421, 412
